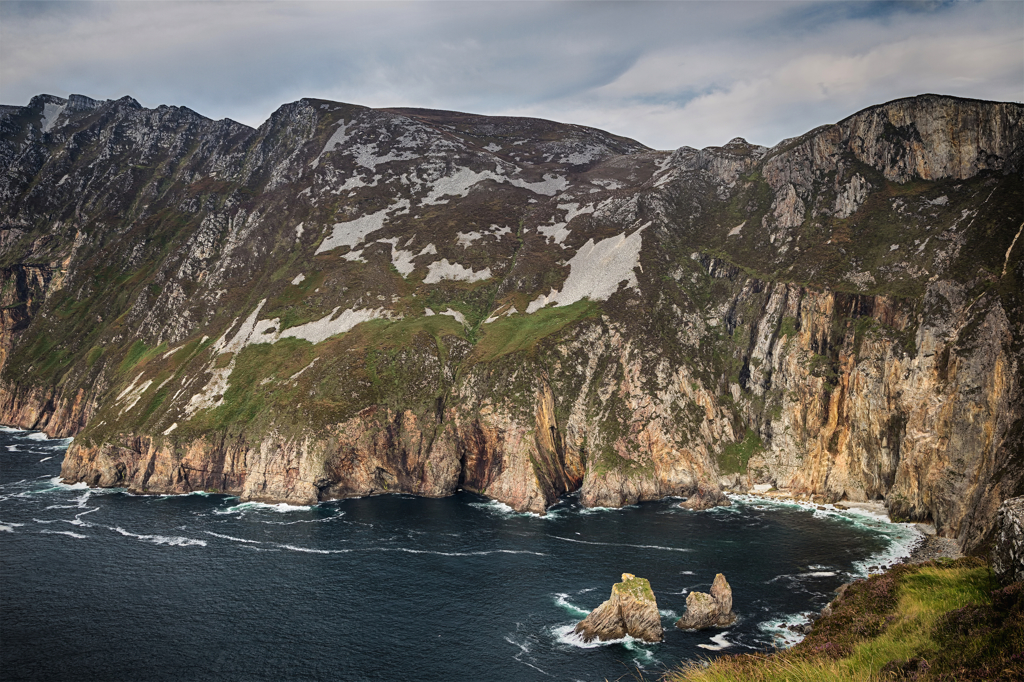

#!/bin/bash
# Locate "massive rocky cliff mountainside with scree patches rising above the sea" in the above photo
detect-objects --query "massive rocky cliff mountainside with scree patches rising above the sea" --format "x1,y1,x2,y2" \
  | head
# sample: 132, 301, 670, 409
0, 95, 1024, 549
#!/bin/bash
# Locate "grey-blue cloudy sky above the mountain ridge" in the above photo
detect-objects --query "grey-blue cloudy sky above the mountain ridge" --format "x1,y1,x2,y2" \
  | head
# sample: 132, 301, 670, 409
0, 0, 1024, 148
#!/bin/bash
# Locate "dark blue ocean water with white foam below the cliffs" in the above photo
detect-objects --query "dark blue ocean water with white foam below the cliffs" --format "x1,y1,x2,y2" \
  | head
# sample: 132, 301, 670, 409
0, 430, 916, 681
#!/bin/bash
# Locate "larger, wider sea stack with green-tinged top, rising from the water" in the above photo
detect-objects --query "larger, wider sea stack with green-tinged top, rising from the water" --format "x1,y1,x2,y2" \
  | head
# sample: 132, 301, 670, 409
573, 573, 662, 642
